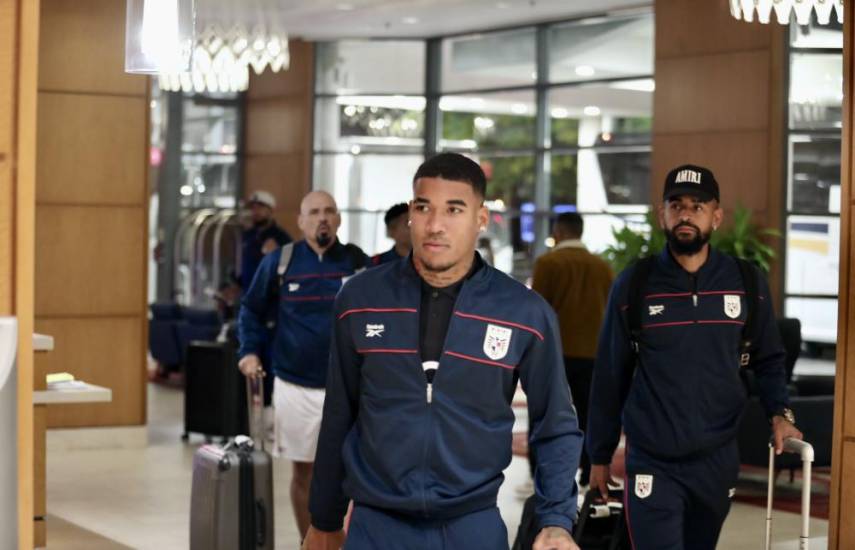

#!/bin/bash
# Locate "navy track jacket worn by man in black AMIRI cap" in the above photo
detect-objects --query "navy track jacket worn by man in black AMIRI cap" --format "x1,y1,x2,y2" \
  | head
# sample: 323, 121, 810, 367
587, 248, 788, 464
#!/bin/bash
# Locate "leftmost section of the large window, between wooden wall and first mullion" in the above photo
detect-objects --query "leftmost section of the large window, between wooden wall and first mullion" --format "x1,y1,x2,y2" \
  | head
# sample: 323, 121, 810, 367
313, 40, 426, 254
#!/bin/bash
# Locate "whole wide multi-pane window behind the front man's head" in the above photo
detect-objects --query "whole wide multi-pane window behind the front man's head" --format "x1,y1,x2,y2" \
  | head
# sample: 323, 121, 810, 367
314, 12, 654, 279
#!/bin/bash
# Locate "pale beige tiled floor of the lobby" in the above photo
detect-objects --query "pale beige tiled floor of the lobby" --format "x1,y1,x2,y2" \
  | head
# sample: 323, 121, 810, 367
48, 378, 828, 550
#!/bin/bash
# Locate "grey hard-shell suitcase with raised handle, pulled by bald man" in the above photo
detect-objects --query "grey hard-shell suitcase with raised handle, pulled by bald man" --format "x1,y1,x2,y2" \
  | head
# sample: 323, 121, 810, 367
190, 380, 274, 550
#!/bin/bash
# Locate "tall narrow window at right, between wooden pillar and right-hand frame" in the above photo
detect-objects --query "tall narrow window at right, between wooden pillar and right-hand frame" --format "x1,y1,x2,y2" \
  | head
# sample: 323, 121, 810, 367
784, 17, 843, 350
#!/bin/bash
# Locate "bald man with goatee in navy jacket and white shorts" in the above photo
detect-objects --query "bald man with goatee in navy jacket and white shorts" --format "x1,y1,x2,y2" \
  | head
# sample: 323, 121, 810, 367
238, 191, 368, 535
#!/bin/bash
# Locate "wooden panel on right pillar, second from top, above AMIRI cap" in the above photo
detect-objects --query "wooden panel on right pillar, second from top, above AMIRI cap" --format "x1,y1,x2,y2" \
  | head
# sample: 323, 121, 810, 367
654, 51, 771, 133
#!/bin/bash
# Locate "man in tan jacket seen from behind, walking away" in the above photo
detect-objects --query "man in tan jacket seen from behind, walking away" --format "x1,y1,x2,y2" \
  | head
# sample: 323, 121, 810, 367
532, 212, 614, 485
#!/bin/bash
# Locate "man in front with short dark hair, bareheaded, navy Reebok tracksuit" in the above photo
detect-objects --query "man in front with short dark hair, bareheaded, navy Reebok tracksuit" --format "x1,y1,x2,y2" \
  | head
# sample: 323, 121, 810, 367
303, 153, 582, 550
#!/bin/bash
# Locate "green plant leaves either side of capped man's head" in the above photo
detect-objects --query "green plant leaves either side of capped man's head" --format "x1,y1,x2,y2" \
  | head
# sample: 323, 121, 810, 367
601, 205, 781, 273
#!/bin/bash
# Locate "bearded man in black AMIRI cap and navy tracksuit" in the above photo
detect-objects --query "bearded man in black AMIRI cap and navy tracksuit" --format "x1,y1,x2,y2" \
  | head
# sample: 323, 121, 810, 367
586, 165, 801, 550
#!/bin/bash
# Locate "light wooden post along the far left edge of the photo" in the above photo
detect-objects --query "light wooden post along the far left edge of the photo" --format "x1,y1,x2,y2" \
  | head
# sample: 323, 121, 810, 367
0, 0, 39, 550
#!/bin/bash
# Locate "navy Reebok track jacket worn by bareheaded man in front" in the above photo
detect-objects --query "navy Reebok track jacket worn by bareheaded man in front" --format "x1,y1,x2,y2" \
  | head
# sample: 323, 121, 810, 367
309, 258, 582, 531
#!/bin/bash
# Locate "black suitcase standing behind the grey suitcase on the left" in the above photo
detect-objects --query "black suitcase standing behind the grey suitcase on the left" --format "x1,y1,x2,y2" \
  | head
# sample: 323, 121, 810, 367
182, 340, 249, 441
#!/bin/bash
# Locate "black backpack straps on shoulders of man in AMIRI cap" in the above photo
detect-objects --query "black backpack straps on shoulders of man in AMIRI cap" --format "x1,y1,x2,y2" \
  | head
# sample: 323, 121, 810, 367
626, 256, 759, 368
